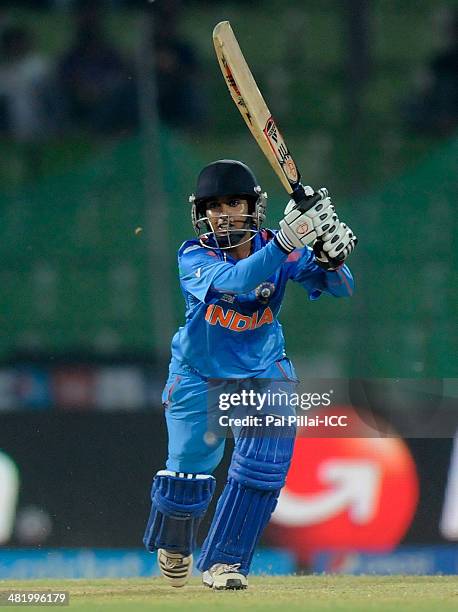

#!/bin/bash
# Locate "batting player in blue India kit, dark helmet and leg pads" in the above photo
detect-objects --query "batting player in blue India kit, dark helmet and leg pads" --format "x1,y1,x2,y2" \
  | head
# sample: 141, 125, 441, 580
143, 160, 357, 590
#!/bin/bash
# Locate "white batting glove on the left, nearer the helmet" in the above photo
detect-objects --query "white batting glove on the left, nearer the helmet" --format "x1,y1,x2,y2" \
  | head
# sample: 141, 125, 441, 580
276, 187, 337, 253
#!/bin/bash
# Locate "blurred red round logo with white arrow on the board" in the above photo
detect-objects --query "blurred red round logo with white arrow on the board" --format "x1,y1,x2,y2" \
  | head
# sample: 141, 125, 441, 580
267, 408, 418, 563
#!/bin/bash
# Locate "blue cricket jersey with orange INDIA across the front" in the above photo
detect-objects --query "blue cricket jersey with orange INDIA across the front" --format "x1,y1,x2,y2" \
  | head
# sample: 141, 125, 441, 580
170, 229, 353, 378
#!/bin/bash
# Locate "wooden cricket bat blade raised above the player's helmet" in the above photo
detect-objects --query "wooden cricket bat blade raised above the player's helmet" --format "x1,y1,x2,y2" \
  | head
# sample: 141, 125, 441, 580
213, 21, 301, 193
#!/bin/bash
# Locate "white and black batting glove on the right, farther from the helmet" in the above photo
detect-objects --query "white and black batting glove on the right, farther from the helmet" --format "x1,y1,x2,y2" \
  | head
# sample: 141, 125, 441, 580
313, 216, 358, 270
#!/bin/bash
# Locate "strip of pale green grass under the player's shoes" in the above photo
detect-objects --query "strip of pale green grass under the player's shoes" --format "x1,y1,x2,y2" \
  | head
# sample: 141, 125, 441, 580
0, 576, 458, 612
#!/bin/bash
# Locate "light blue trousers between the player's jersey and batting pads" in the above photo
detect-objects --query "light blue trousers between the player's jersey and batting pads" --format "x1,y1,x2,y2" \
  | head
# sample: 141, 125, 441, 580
162, 358, 297, 474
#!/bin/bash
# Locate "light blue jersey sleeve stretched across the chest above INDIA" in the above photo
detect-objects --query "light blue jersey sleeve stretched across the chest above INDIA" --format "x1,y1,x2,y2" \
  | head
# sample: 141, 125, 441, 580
178, 240, 287, 302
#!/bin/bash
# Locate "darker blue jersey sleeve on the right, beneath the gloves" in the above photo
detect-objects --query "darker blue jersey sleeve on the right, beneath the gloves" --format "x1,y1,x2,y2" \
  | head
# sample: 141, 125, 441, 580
285, 247, 355, 300
